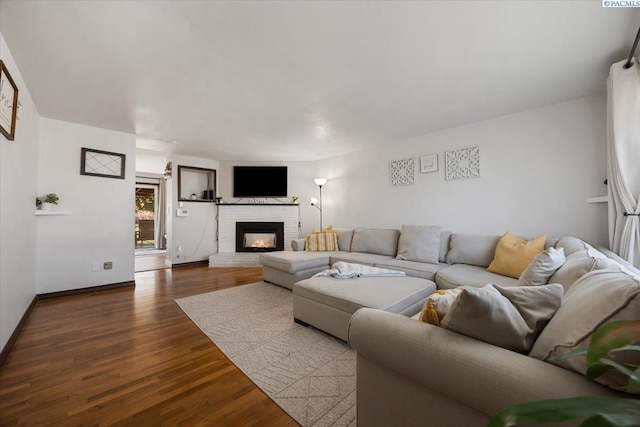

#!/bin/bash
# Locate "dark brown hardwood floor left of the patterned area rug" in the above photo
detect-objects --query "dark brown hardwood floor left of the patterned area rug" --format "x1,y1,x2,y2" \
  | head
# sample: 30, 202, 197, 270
0, 266, 297, 426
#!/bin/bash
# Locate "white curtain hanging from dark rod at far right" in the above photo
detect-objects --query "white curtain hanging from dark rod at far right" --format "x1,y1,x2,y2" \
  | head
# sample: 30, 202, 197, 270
607, 58, 640, 267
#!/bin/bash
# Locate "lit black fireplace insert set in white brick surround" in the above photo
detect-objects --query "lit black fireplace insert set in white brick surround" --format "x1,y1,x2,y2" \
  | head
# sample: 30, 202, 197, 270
236, 222, 284, 252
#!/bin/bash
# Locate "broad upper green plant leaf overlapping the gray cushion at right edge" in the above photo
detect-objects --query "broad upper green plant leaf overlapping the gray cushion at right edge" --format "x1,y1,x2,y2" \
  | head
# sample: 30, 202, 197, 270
587, 320, 640, 366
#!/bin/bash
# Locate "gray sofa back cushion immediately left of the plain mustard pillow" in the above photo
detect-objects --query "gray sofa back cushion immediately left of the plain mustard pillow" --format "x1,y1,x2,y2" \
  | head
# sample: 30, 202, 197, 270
446, 233, 501, 268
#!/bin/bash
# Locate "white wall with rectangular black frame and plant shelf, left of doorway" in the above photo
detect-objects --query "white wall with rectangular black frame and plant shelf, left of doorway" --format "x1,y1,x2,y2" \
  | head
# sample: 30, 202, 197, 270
37, 118, 135, 293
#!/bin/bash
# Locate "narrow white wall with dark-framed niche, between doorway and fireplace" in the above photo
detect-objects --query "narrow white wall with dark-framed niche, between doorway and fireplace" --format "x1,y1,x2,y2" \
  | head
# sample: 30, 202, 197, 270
167, 155, 219, 265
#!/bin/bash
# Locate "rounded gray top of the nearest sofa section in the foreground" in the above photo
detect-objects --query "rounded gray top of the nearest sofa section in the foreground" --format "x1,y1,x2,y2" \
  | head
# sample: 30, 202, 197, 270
349, 308, 615, 416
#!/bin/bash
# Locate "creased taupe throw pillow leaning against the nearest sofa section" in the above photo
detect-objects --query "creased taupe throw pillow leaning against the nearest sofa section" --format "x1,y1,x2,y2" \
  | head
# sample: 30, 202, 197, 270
440, 283, 563, 353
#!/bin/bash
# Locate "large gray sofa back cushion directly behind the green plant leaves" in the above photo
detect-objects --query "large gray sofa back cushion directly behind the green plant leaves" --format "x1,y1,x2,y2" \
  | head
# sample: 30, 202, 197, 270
529, 266, 640, 390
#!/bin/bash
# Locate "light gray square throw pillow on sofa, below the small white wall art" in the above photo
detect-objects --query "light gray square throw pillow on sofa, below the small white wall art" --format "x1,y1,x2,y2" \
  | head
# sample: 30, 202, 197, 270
396, 225, 442, 264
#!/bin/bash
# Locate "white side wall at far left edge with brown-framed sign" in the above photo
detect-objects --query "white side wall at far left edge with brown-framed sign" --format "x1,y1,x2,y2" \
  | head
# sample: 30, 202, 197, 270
0, 34, 40, 350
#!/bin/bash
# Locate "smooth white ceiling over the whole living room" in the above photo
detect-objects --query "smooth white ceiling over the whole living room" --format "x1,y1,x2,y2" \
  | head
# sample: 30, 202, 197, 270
0, 0, 640, 161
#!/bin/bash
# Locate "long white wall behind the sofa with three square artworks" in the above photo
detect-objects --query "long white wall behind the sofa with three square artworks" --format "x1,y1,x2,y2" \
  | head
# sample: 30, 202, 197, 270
317, 96, 608, 245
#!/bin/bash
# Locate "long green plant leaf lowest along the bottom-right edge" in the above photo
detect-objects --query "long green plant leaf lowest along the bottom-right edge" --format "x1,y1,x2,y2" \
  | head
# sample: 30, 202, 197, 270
487, 396, 640, 427
